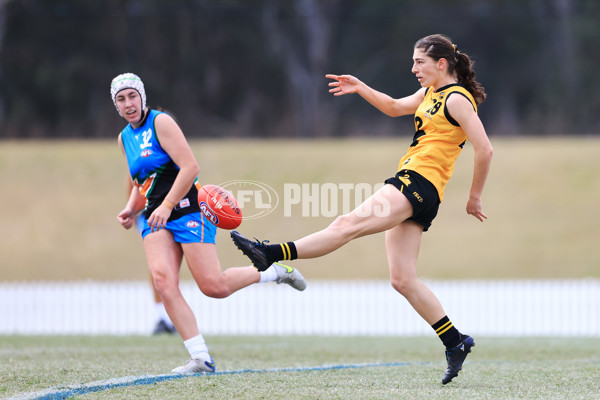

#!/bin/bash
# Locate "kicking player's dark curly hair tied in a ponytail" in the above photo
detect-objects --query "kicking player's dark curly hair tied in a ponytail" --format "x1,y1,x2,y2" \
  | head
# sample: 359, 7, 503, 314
415, 34, 487, 104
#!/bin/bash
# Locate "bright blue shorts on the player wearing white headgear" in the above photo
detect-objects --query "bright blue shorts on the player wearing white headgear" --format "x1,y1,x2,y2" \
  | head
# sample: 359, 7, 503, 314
141, 212, 217, 244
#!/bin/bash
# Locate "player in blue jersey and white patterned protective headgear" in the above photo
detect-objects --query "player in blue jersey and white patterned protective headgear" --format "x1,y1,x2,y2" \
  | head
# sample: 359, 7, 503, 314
110, 73, 306, 374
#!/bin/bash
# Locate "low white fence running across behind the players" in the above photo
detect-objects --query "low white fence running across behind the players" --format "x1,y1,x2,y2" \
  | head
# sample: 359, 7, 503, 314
0, 279, 600, 336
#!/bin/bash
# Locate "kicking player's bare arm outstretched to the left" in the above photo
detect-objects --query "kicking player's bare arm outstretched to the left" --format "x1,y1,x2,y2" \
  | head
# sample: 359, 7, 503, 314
325, 74, 425, 117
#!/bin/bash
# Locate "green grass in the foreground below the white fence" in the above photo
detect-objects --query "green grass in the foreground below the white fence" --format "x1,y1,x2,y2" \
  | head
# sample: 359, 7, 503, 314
0, 336, 600, 399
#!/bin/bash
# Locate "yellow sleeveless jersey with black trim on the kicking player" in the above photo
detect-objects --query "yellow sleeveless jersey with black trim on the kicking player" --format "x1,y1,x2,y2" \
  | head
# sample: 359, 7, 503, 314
398, 84, 477, 201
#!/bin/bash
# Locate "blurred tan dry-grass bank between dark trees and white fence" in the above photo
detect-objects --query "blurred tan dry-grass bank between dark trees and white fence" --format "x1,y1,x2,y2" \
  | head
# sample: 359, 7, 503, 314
0, 137, 600, 281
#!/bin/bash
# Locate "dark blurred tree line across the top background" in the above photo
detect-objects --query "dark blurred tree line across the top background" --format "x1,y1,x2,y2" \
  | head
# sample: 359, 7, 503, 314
0, 0, 600, 138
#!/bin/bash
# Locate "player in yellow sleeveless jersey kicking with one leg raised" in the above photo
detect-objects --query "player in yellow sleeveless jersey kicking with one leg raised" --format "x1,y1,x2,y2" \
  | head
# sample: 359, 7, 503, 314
231, 34, 493, 384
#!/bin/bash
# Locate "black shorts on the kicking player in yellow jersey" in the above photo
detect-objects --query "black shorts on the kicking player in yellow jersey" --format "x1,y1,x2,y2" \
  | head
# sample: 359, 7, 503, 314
385, 169, 440, 232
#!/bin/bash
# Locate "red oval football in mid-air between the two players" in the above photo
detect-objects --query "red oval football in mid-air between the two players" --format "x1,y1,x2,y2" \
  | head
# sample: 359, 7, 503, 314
198, 185, 242, 229
